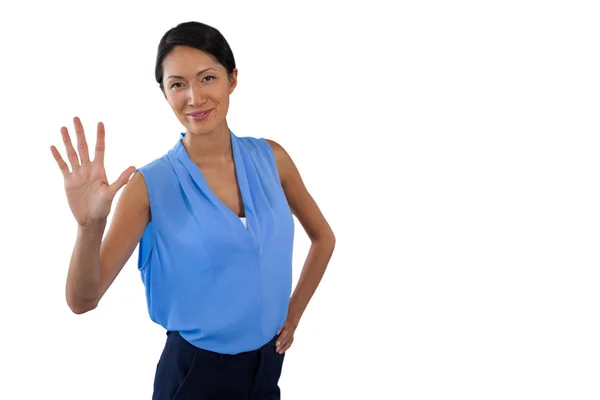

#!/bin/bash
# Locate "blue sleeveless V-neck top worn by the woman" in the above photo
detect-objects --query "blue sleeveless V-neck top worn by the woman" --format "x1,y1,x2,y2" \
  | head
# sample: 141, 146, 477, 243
138, 131, 294, 354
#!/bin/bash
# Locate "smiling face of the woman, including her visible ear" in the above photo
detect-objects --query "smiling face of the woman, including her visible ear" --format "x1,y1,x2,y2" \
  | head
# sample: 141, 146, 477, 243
163, 46, 237, 134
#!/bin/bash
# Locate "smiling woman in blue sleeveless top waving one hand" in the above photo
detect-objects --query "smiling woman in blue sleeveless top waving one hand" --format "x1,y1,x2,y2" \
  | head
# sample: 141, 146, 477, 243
51, 22, 335, 399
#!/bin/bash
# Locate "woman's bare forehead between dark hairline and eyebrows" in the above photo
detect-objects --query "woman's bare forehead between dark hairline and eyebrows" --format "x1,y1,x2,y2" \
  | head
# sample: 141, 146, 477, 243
163, 46, 223, 77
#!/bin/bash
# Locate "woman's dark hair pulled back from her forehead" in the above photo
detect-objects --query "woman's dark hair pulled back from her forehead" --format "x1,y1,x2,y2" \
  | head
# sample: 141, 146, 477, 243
154, 21, 235, 91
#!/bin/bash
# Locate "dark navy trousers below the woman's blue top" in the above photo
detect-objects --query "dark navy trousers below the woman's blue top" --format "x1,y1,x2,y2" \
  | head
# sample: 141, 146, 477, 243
152, 332, 285, 400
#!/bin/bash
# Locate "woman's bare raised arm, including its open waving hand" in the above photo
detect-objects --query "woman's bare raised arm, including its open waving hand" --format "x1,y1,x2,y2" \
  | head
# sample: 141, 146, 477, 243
50, 117, 150, 314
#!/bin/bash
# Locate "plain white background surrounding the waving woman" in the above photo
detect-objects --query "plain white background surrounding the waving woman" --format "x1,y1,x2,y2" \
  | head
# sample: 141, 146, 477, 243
0, 0, 600, 400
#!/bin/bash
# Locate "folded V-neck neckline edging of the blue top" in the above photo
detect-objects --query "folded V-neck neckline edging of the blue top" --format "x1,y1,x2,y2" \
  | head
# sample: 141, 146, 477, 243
178, 130, 254, 233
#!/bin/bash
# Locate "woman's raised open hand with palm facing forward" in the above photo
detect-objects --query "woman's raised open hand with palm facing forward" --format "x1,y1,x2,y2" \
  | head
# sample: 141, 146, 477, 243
50, 117, 135, 227
